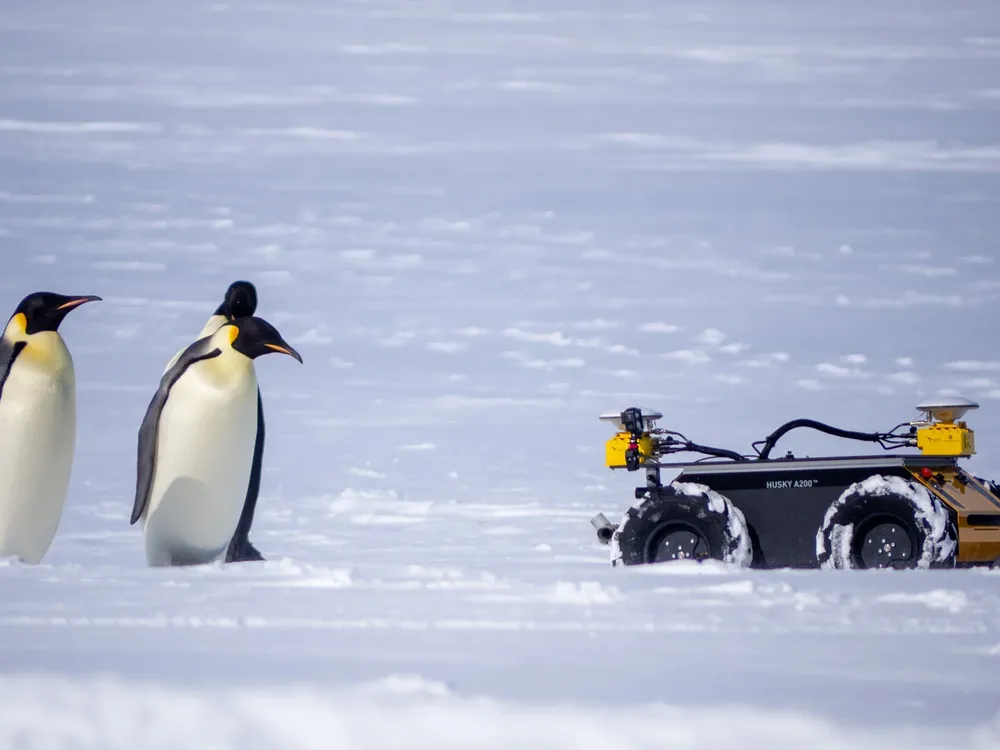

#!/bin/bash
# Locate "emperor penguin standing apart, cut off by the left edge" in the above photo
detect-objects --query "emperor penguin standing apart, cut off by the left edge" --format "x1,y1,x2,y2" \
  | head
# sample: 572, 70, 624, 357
0, 292, 101, 565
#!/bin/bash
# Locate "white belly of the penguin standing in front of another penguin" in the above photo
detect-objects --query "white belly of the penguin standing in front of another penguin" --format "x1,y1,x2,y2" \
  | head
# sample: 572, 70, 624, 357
143, 371, 257, 565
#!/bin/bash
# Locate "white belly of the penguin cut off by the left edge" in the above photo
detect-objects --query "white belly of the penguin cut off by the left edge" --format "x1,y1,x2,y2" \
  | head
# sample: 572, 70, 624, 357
0, 362, 76, 564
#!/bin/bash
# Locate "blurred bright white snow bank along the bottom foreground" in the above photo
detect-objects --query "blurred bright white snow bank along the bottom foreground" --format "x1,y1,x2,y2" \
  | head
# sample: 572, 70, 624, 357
0, 676, 1000, 750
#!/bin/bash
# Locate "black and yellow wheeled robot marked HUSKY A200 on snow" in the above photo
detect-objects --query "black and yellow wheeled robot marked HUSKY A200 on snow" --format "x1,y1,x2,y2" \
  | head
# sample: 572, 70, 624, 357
591, 398, 1000, 569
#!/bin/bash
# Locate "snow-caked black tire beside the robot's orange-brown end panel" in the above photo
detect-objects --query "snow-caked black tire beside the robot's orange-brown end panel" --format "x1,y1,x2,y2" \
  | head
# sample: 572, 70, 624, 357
816, 476, 958, 569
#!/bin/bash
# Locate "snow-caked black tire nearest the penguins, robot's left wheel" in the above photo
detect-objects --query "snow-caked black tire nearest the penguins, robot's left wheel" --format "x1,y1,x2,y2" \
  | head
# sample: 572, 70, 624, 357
611, 483, 753, 567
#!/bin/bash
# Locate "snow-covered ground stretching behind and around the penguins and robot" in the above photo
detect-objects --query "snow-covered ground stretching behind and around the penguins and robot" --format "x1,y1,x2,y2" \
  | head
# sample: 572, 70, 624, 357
0, 0, 1000, 750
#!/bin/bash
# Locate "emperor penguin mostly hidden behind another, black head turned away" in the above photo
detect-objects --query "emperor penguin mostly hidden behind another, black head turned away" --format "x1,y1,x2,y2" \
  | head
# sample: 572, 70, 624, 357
164, 279, 264, 563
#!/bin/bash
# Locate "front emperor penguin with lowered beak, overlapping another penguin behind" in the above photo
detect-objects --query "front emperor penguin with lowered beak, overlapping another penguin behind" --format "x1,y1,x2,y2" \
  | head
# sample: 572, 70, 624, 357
130, 317, 302, 567
